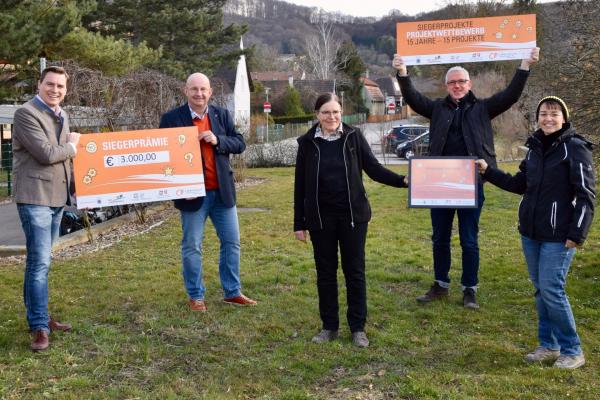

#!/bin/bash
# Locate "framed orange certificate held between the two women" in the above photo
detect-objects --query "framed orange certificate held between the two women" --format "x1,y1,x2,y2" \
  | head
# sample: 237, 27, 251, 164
408, 157, 478, 208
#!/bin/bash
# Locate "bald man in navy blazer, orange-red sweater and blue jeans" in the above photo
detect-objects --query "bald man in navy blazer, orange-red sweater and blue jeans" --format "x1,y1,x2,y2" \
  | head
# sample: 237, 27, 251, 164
160, 73, 256, 311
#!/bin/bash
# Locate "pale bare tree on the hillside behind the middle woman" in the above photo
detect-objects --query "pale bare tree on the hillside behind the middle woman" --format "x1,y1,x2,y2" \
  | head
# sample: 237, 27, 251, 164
305, 21, 347, 79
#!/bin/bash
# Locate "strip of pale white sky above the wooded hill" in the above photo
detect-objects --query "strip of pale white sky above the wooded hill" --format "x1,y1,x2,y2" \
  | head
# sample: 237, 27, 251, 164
284, 0, 555, 17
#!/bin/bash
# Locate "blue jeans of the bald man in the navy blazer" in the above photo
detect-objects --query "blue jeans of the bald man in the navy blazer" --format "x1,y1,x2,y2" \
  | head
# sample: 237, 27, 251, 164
181, 190, 241, 300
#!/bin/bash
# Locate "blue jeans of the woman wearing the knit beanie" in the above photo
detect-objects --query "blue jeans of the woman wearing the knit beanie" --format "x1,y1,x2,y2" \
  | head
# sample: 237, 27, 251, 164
521, 236, 581, 355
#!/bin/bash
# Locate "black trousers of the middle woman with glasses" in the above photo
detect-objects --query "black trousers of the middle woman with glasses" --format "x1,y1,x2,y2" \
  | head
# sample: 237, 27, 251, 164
310, 217, 368, 332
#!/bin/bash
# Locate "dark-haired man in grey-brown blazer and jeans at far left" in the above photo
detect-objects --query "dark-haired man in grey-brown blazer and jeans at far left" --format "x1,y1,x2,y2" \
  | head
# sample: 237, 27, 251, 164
13, 67, 79, 351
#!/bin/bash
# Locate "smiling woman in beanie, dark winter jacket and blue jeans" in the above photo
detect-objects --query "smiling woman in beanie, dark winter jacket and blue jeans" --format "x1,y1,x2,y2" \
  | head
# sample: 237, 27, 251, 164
477, 96, 596, 369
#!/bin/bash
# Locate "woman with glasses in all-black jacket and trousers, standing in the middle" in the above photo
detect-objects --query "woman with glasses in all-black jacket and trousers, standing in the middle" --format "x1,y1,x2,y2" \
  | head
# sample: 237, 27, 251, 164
294, 93, 407, 347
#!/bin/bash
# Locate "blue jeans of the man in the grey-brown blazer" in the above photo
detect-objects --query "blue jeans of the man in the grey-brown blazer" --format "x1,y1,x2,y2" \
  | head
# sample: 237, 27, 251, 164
17, 203, 63, 332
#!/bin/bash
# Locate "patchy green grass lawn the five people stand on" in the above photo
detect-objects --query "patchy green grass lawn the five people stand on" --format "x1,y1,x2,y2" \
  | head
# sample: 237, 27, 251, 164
0, 164, 600, 399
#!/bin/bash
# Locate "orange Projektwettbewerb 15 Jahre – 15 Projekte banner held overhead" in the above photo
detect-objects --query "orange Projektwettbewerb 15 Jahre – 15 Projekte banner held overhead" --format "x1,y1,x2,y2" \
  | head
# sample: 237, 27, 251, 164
396, 14, 536, 65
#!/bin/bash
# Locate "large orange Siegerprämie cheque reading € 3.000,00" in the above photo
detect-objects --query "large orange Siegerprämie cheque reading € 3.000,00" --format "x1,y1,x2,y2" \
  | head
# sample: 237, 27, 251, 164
74, 126, 206, 209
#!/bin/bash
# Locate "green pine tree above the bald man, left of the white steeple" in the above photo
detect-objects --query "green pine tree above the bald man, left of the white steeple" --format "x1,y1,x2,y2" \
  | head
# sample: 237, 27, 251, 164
85, 0, 246, 78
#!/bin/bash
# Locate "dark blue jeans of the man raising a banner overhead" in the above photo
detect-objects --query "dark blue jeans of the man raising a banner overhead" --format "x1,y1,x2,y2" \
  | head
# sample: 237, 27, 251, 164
431, 184, 485, 288
